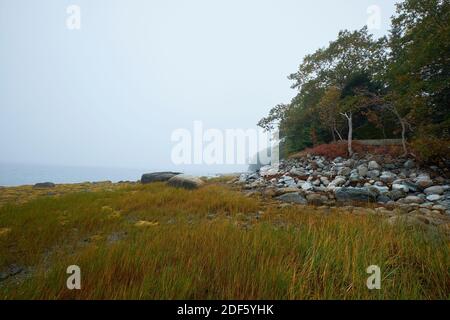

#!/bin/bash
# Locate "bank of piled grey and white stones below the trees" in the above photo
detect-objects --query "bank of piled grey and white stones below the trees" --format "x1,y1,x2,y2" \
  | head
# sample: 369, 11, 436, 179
236, 155, 450, 215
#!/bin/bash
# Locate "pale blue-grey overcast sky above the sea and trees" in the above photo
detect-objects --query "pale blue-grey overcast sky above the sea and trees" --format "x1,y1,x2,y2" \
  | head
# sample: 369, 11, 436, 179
0, 0, 394, 174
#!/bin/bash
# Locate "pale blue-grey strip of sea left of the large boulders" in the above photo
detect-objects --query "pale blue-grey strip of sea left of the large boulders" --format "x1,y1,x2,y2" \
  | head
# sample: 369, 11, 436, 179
0, 163, 147, 186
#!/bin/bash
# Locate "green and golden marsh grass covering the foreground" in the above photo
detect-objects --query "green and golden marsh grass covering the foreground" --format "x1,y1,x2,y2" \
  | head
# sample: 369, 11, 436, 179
0, 183, 450, 299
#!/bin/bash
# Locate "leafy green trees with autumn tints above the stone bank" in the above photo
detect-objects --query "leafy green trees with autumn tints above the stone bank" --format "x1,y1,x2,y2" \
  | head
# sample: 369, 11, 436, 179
258, 0, 450, 161
